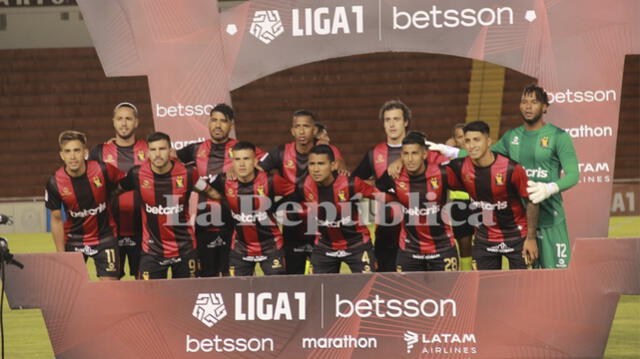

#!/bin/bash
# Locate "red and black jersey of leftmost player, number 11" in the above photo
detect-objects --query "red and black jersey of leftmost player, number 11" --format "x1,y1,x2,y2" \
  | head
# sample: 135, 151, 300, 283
45, 161, 124, 247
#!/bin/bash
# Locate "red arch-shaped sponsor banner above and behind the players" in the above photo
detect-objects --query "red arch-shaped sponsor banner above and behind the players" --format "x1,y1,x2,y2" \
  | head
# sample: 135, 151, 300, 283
77, 0, 640, 258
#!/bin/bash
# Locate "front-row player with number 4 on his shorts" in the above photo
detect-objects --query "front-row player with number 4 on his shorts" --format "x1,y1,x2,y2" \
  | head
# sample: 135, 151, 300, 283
281, 145, 377, 273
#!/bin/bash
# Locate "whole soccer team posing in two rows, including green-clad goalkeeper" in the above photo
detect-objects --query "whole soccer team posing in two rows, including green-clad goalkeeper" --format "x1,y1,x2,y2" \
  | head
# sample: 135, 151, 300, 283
45, 86, 578, 280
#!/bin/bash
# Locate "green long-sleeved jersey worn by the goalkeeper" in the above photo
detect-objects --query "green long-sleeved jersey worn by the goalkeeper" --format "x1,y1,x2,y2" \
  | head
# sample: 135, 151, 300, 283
492, 123, 578, 228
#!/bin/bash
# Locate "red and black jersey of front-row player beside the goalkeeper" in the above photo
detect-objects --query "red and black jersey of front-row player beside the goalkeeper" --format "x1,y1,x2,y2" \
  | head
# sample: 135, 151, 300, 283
447, 152, 529, 242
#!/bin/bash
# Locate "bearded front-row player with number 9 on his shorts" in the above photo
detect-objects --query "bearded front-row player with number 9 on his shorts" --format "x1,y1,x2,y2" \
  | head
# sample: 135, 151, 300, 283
118, 132, 220, 280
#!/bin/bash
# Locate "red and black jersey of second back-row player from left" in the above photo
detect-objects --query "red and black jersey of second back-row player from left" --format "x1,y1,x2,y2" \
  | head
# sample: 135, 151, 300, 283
177, 139, 264, 232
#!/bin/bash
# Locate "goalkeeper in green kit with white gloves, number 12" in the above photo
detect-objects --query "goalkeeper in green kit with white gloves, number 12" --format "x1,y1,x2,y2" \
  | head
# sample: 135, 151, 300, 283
429, 85, 578, 268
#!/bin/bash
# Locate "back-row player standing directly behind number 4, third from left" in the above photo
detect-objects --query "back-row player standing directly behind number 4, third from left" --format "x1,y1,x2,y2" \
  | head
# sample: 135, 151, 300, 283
258, 110, 346, 274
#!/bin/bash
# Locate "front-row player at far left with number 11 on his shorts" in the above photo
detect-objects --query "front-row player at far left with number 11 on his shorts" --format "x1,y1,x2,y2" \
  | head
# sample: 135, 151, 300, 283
45, 131, 124, 280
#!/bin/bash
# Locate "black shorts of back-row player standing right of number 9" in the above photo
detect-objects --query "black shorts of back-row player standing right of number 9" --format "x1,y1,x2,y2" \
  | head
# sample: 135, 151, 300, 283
196, 227, 233, 277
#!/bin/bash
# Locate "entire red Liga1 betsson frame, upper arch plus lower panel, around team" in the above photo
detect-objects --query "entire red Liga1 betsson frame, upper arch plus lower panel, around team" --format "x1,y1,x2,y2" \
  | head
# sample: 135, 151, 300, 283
2, 0, 640, 358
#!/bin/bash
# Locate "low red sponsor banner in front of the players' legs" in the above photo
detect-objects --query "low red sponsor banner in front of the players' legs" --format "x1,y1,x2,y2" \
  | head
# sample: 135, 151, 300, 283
5, 238, 640, 359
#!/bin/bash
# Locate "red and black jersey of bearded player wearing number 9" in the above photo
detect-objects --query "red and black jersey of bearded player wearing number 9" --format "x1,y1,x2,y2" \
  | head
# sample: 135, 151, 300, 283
120, 161, 200, 258
